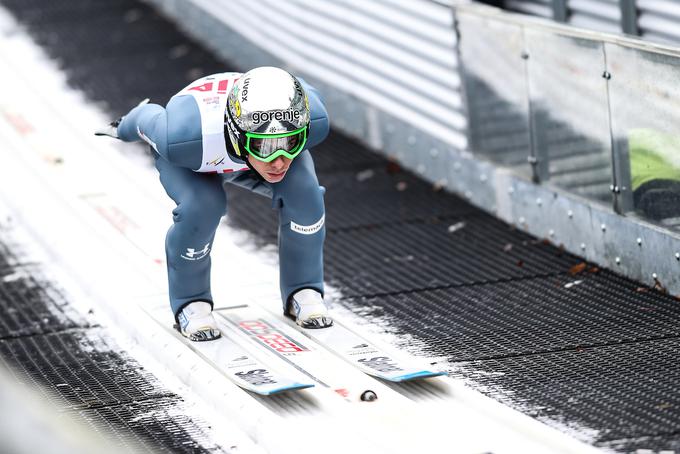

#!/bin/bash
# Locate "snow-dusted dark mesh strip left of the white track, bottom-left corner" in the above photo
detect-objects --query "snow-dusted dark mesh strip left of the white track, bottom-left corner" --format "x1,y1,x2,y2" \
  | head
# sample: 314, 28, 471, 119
0, 239, 222, 453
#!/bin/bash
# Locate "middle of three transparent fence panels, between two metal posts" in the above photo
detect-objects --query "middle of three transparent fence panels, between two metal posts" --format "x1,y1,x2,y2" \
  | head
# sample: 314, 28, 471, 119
525, 28, 613, 205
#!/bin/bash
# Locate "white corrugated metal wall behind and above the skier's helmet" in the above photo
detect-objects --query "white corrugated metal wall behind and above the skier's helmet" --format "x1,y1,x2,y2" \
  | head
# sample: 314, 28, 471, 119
161, 0, 466, 147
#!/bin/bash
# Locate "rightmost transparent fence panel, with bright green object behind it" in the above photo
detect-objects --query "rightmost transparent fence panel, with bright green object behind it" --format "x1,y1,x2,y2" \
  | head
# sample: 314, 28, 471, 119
605, 43, 680, 230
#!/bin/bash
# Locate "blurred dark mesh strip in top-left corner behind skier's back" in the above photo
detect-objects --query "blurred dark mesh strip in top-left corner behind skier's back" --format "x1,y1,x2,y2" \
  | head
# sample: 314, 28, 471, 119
0, 0, 228, 116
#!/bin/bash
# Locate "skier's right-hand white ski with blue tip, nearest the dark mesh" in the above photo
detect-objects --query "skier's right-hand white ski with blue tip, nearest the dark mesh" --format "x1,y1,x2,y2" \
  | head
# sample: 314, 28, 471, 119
290, 319, 446, 383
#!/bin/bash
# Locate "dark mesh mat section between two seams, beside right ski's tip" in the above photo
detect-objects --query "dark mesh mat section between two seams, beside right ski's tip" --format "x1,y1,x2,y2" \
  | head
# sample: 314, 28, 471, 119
342, 271, 680, 362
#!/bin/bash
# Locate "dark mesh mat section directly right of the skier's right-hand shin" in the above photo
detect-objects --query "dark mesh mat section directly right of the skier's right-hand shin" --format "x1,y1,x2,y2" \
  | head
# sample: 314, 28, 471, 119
325, 217, 580, 296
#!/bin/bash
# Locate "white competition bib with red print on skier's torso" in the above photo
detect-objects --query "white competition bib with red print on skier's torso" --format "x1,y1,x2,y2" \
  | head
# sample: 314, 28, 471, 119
175, 73, 248, 173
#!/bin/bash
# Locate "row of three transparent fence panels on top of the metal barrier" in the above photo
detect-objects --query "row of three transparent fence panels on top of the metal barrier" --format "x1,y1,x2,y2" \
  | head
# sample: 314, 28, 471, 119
457, 2, 680, 223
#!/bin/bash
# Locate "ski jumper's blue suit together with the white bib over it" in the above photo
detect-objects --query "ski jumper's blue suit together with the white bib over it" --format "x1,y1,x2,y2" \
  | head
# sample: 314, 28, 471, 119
118, 73, 329, 317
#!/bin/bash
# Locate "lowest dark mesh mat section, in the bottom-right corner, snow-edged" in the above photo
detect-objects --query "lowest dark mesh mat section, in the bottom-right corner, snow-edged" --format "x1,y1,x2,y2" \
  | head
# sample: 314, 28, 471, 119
452, 339, 680, 446
